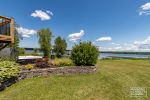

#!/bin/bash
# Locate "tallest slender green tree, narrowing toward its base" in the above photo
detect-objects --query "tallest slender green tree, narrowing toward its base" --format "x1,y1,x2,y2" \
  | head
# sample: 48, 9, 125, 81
38, 28, 52, 57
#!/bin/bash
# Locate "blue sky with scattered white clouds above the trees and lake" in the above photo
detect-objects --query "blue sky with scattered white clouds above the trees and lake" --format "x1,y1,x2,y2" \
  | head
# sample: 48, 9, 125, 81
0, 0, 150, 51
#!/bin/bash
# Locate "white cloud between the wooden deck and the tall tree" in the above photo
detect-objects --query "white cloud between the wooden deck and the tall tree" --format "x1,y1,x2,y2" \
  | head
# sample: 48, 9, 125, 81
16, 27, 37, 38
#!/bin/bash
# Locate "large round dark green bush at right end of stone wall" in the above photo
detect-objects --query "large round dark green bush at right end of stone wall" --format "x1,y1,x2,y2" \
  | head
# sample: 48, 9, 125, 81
71, 42, 99, 66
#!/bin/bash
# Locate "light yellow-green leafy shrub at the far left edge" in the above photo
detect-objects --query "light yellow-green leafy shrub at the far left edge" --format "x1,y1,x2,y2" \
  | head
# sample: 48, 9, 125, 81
0, 61, 19, 82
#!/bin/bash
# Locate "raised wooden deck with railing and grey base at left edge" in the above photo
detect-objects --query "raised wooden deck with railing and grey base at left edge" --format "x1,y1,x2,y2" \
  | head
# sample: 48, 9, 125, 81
0, 16, 15, 58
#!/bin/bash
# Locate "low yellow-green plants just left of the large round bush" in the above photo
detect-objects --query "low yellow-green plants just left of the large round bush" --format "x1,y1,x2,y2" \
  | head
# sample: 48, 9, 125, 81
53, 58, 74, 67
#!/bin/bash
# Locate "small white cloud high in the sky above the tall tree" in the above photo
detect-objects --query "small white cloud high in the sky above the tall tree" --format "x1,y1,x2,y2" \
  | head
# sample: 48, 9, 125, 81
31, 10, 53, 21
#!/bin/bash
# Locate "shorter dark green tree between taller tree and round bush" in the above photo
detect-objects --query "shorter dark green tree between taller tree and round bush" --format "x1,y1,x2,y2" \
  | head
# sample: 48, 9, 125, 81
54, 36, 67, 58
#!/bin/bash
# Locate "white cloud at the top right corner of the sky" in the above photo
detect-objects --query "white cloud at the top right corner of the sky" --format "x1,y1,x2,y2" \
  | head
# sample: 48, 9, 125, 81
139, 2, 150, 16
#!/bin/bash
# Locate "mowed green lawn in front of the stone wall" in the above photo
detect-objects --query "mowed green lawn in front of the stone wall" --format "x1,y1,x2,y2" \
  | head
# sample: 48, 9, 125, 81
0, 60, 150, 100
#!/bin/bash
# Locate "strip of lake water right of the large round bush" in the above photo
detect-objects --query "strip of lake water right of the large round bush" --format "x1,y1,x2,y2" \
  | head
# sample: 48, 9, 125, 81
100, 53, 150, 58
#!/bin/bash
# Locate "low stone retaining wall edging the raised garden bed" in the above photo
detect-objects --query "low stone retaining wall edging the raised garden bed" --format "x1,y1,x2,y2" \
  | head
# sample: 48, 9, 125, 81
18, 66, 97, 80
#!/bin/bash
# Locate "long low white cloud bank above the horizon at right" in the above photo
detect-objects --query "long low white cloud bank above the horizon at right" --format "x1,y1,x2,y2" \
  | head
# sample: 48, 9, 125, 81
100, 36, 150, 52
